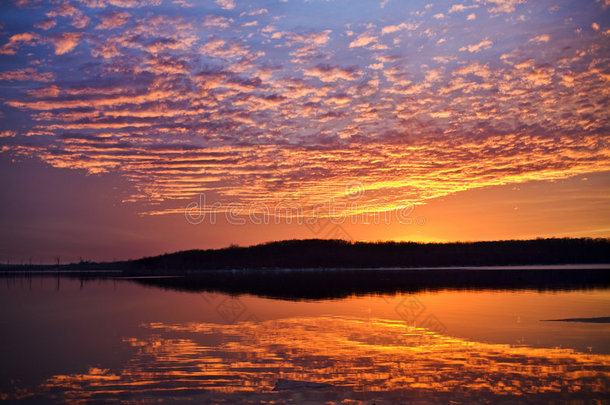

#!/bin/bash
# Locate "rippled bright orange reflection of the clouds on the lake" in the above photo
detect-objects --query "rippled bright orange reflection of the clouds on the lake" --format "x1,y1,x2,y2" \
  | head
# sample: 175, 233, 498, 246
21, 317, 610, 404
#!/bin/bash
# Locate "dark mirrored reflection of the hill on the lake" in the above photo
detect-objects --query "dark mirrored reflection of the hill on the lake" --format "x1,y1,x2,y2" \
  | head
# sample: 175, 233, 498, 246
0, 264, 610, 300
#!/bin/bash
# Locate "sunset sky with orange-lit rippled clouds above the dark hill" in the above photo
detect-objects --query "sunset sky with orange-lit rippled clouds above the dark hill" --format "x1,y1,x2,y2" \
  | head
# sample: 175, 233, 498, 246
0, 0, 610, 263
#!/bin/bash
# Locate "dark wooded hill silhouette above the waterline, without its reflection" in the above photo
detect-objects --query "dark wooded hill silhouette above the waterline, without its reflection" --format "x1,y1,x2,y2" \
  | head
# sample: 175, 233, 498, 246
131, 238, 610, 273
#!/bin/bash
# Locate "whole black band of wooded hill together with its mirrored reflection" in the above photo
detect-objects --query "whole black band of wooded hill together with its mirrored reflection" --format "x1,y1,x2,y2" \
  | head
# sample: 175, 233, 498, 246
0, 239, 610, 299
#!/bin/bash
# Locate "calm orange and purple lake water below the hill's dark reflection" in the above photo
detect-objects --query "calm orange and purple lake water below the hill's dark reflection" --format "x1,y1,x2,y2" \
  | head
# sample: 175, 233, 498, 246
0, 278, 610, 405
